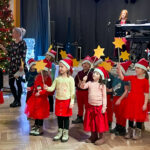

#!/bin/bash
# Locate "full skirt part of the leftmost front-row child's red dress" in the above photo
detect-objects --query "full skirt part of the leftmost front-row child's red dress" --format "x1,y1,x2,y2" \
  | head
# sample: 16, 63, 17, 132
25, 94, 50, 119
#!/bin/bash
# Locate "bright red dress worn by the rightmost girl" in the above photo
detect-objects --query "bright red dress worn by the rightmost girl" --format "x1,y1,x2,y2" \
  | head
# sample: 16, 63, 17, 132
124, 76, 149, 122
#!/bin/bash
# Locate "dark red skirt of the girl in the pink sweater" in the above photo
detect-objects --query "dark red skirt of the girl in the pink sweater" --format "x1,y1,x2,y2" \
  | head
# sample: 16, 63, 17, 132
84, 104, 109, 133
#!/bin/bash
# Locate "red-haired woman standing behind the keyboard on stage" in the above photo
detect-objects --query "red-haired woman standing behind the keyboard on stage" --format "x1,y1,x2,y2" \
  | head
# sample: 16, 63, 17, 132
115, 9, 130, 57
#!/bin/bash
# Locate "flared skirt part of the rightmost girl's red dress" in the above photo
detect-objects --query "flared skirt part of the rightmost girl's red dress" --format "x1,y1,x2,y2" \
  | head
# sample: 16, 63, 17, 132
125, 93, 148, 122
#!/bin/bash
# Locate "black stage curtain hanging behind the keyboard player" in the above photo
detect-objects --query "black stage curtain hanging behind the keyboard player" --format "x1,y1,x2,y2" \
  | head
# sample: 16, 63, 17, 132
50, 0, 150, 58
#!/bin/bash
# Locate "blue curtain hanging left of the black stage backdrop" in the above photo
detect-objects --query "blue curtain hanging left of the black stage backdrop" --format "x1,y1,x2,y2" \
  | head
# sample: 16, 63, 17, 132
21, 0, 50, 59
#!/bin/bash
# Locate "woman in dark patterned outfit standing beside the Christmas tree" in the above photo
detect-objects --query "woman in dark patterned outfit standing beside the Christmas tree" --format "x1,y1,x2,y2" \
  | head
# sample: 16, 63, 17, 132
0, 28, 27, 107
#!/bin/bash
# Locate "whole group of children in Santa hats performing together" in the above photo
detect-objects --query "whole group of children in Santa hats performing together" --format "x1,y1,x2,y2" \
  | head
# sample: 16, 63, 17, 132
0, 47, 149, 145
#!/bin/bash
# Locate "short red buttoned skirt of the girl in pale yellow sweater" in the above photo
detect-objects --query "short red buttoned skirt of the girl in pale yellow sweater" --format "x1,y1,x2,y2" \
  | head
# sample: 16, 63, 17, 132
55, 99, 72, 117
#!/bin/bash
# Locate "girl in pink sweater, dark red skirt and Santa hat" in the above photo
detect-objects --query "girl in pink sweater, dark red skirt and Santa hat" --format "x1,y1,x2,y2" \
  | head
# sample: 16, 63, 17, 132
81, 67, 108, 145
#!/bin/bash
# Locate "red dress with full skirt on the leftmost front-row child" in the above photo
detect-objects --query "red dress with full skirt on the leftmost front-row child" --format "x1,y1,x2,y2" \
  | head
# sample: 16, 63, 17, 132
25, 74, 52, 119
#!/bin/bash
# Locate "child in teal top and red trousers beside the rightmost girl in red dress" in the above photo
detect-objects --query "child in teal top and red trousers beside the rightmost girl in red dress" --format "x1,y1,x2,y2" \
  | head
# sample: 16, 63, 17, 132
108, 61, 131, 136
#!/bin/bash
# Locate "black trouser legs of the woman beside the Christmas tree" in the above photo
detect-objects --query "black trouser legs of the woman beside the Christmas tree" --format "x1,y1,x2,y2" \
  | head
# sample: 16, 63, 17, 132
9, 78, 22, 103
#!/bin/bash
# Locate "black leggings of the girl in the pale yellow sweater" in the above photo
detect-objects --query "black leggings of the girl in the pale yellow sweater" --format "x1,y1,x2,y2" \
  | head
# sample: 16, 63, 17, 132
57, 116, 69, 130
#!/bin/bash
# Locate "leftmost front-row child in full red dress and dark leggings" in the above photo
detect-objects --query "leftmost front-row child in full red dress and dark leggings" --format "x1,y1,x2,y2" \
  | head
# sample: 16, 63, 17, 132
25, 64, 51, 136
